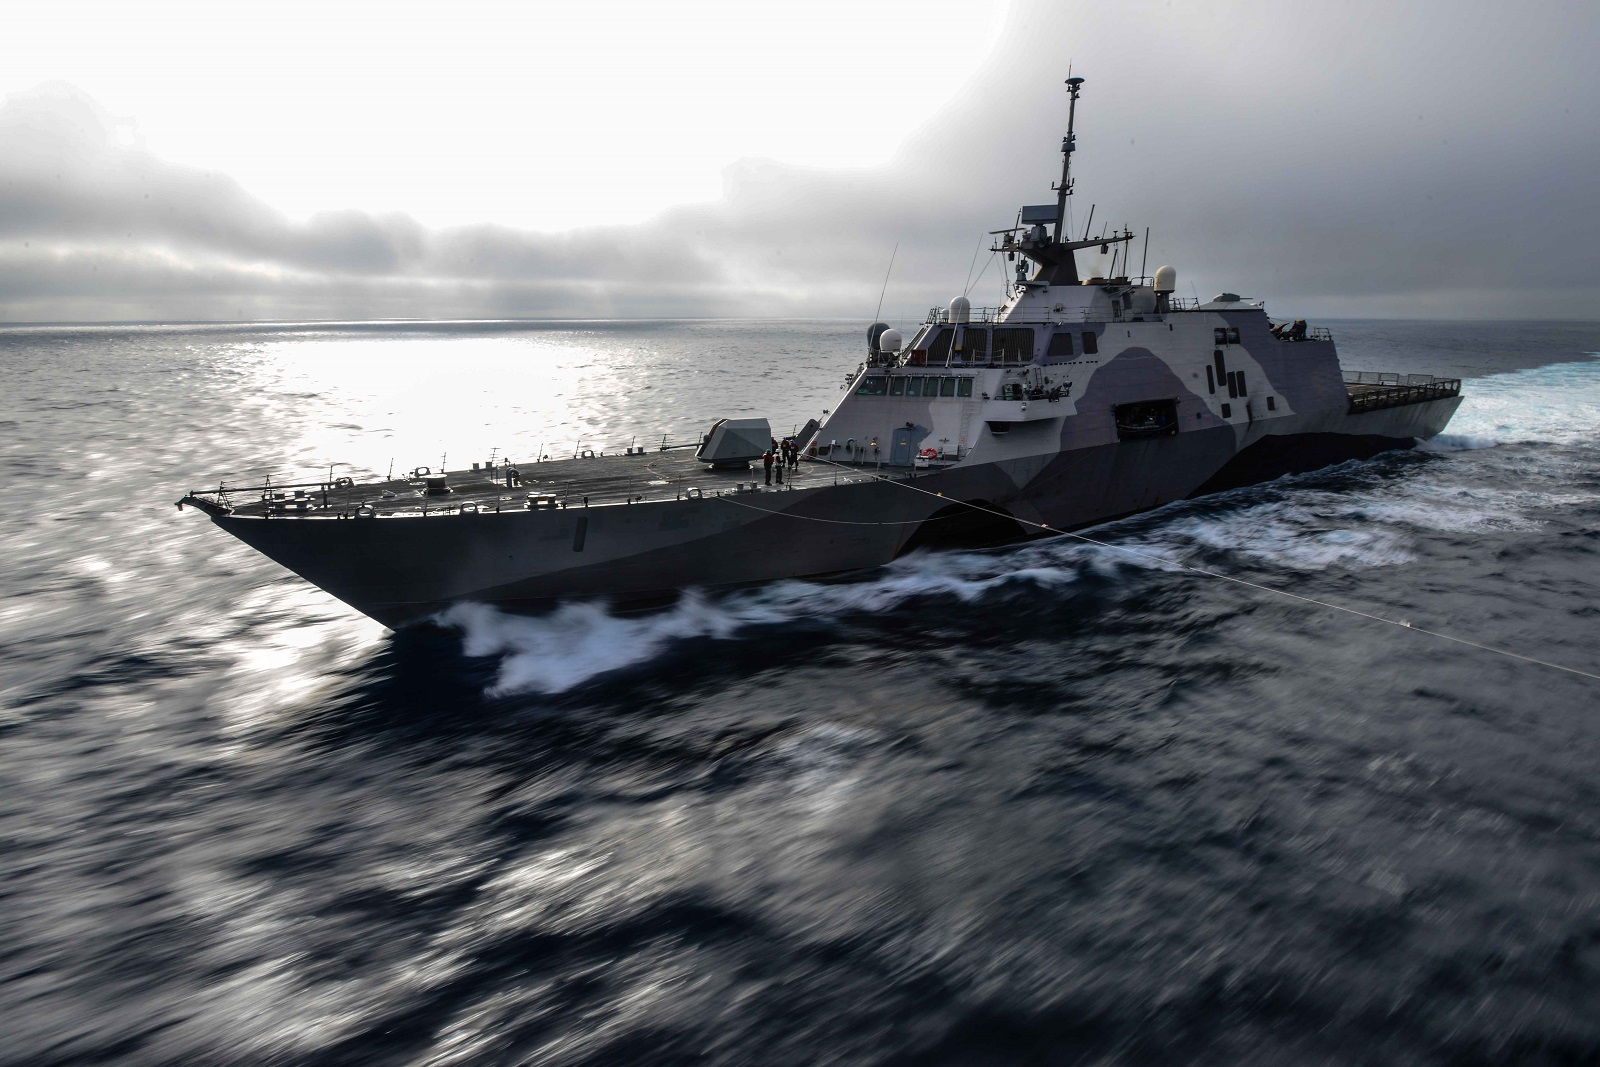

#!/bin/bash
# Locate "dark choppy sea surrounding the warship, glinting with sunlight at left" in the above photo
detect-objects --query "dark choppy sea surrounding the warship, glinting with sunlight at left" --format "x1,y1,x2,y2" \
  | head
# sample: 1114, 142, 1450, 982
0, 323, 1600, 1065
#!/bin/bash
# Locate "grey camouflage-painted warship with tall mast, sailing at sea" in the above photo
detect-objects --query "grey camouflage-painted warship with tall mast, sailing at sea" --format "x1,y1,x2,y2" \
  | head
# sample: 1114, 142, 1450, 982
179, 78, 1461, 627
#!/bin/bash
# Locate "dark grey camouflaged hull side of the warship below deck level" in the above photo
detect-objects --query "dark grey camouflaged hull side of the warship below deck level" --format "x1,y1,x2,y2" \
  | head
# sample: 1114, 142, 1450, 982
203, 397, 1459, 627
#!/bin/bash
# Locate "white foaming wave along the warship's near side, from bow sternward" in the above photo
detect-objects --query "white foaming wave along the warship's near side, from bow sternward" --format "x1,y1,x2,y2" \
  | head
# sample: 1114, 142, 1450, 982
437, 490, 1533, 696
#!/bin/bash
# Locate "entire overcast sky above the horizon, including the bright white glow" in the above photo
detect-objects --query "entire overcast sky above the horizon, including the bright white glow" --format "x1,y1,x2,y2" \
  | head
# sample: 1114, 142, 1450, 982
0, 0, 1600, 322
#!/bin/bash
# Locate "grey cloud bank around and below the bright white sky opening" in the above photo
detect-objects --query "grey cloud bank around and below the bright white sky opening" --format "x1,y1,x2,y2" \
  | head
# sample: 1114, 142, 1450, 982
0, 0, 1600, 322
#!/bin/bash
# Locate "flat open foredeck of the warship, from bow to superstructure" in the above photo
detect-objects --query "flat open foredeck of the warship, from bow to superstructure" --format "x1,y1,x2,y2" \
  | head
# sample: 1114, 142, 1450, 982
179, 450, 910, 518
